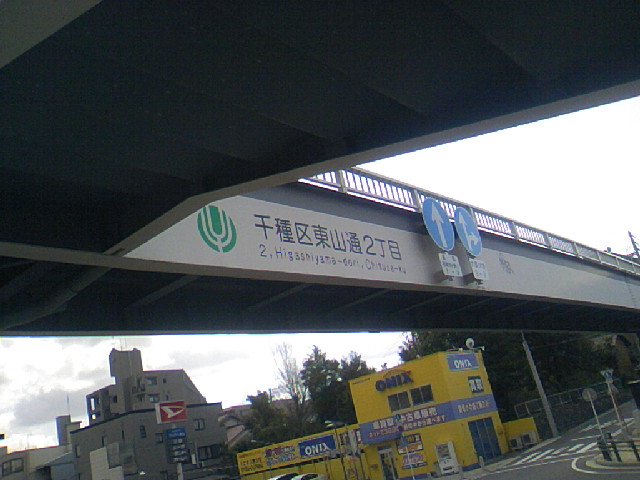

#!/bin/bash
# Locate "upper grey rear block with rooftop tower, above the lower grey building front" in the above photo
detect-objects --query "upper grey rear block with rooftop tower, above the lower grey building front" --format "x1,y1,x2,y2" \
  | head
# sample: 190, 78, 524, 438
87, 348, 207, 425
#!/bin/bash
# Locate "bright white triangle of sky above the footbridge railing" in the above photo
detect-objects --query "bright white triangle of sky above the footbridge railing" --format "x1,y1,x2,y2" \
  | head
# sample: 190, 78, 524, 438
366, 93, 640, 253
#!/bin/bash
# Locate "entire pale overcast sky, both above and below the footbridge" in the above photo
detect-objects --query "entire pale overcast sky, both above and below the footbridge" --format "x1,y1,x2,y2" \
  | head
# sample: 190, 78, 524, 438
0, 98, 640, 450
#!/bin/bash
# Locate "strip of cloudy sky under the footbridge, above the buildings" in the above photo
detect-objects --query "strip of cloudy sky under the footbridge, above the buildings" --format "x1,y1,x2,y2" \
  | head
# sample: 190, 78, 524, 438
0, 333, 401, 450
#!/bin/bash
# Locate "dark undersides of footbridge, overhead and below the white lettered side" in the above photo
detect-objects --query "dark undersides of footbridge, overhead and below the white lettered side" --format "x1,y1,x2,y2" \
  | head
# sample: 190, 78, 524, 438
0, 0, 640, 333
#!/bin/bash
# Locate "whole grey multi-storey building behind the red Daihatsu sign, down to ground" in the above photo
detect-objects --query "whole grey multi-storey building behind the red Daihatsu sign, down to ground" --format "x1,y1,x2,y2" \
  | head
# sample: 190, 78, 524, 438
76, 349, 227, 480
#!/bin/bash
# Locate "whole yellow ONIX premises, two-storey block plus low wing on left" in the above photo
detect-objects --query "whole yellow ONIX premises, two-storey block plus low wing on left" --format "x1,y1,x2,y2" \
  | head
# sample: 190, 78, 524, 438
238, 350, 537, 480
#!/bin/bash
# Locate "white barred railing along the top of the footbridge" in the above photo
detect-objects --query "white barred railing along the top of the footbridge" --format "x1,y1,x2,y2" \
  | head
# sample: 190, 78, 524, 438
300, 168, 640, 276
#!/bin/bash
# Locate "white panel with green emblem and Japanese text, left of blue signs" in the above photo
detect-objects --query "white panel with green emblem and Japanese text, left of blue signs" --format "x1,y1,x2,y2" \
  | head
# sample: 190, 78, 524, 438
128, 196, 430, 282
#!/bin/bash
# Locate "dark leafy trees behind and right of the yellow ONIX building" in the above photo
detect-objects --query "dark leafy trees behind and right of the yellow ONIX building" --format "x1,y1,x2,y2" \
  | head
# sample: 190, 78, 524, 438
400, 331, 608, 420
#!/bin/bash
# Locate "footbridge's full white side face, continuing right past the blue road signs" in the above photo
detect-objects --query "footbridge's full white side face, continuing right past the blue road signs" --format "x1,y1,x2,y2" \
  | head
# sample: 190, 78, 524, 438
127, 196, 640, 309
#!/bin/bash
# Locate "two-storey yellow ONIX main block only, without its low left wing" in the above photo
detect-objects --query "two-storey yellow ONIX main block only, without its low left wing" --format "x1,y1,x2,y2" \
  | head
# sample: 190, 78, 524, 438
351, 350, 508, 480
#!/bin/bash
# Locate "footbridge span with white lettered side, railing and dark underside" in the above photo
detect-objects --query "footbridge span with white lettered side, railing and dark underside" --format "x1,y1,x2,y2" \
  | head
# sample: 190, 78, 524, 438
0, 169, 640, 334
